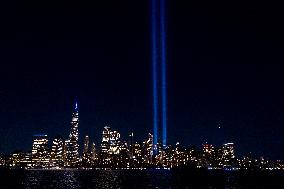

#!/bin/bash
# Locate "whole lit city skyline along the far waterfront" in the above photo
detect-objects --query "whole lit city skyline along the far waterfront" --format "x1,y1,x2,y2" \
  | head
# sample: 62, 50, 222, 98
0, 101, 284, 171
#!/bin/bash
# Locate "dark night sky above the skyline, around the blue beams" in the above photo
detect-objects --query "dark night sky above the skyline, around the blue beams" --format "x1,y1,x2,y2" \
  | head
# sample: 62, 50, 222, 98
0, 0, 284, 159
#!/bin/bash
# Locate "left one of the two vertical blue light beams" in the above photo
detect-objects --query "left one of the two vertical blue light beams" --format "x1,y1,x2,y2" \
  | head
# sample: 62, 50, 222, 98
151, 0, 158, 151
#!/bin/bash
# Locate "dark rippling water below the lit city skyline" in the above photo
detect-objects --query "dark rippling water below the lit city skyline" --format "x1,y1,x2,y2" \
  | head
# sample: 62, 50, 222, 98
0, 170, 284, 189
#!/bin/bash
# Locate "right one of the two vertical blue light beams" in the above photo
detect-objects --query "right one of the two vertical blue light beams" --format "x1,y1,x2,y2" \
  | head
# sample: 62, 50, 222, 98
160, 0, 167, 147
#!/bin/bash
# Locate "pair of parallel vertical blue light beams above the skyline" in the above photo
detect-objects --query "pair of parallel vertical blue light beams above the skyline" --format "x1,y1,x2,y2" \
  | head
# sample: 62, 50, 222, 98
151, 0, 167, 149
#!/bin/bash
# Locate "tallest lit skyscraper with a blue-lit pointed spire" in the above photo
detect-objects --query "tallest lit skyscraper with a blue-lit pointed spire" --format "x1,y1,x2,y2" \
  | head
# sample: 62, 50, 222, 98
65, 102, 80, 167
